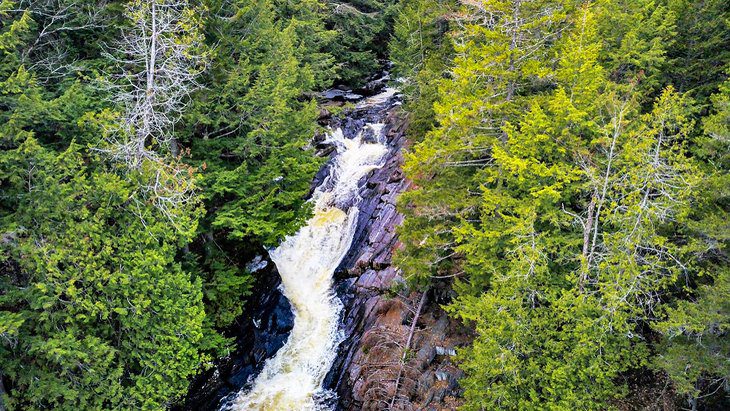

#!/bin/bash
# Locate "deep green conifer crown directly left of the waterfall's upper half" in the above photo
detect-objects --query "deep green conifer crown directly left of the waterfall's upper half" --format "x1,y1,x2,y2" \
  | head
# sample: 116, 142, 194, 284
185, 2, 319, 244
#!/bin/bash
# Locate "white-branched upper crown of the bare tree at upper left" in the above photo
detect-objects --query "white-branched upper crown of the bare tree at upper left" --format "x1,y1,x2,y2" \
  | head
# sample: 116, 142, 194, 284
102, 0, 206, 169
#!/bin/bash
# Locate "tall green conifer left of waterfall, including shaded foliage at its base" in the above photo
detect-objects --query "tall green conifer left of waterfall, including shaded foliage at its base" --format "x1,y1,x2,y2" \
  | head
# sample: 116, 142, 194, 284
173, 1, 328, 327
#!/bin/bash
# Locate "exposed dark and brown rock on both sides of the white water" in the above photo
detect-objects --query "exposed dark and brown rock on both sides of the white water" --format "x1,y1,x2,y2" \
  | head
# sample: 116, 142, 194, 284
178, 73, 468, 410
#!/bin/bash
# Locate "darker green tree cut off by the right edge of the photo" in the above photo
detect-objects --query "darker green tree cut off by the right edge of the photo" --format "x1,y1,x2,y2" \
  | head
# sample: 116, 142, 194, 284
654, 71, 730, 398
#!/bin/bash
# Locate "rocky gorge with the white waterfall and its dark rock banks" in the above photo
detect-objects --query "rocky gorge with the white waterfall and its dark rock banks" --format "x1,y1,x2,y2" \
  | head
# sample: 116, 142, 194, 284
180, 73, 463, 410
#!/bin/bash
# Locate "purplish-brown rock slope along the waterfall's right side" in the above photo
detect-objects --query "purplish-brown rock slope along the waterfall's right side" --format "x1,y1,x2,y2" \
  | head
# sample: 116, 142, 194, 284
325, 109, 469, 410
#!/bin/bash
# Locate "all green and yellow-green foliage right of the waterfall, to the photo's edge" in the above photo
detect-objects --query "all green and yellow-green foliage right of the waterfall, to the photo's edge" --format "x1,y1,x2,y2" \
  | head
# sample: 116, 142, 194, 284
393, 0, 728, 410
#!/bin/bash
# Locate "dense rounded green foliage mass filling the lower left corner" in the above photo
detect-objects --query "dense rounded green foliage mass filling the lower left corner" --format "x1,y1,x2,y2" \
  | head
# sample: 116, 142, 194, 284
0, 137, 204, 409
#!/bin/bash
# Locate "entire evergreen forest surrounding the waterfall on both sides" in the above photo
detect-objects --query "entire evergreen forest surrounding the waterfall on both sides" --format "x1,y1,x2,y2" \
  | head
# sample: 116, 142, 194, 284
0, 0, 730, 410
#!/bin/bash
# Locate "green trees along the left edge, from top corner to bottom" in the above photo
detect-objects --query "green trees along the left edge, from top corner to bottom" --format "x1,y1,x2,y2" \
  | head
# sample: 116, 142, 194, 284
0, 2, 204, 410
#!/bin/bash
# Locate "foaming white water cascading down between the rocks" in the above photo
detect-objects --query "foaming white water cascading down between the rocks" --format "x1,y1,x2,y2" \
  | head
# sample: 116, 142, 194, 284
223, 92, 388, 411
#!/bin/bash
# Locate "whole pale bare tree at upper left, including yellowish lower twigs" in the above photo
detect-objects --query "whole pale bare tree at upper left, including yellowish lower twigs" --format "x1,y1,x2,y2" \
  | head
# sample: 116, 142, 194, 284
98, 0, 207, 223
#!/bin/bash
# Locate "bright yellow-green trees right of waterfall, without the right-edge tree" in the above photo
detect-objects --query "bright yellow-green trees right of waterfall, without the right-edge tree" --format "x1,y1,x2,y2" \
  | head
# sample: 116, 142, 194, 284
398, 2, 724, 409
